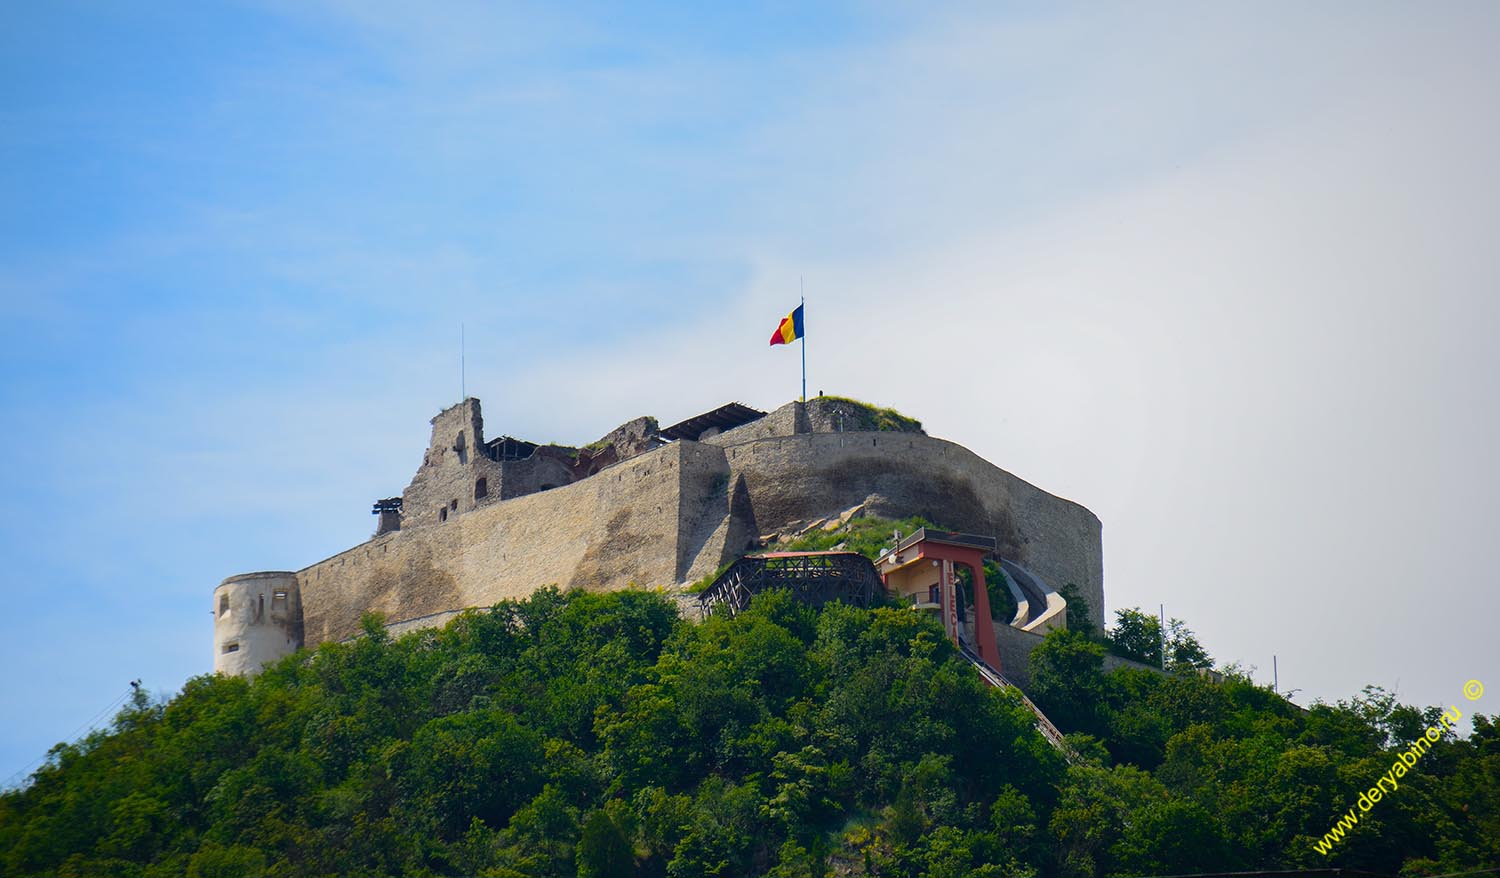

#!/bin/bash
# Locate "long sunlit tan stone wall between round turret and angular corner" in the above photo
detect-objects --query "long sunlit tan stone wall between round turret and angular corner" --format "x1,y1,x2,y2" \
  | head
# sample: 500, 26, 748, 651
297, 443, 707, 645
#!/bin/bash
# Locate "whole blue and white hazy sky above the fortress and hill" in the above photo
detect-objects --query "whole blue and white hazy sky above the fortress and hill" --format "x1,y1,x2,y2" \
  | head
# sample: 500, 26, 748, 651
0, 0, 1500, 777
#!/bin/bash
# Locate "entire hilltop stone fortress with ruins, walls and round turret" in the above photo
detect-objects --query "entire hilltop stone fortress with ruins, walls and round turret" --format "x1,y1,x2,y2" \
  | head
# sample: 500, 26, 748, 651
213, 396, 1104, 681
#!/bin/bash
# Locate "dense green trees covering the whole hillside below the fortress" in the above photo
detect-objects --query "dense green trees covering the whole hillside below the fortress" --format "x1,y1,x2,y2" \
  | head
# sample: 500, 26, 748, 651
0, 590, 1500, 878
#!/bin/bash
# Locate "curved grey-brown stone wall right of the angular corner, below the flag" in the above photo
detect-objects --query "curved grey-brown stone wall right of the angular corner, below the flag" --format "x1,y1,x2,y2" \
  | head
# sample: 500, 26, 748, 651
725, 432, 1104, 624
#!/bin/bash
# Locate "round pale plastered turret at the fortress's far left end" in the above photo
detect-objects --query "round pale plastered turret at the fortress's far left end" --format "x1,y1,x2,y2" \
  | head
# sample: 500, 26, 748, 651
213, 570, 302, 675
